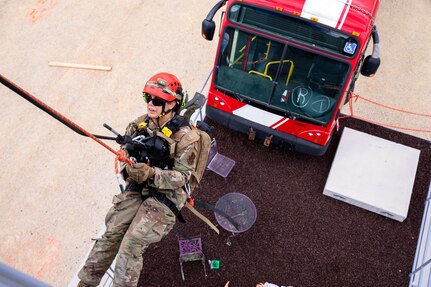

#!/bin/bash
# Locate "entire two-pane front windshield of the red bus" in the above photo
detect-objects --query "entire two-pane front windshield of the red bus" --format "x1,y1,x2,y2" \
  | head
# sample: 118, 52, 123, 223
214, 27, 349, 124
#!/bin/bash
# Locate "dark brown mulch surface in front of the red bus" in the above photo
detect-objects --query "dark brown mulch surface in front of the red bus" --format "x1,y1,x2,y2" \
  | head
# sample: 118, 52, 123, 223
140, 118, 431, 287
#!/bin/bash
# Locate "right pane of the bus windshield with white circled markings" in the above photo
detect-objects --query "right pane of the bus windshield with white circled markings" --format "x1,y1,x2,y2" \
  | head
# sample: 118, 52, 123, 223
270, 46, 349, 123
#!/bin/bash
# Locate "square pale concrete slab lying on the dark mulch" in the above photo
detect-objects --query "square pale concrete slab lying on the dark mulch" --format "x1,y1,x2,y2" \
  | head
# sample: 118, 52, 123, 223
323, 128, 420, 222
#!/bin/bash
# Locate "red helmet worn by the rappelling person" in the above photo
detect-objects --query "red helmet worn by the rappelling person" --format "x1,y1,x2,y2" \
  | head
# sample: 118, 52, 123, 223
144, 73, 182, 102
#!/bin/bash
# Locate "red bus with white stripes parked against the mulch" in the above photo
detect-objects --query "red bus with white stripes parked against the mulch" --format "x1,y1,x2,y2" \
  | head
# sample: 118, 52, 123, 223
202, 0, 380, 155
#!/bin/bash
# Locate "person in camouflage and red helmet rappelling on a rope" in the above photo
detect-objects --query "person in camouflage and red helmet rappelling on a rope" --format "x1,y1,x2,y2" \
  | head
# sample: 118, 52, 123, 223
78, 73, 199, 287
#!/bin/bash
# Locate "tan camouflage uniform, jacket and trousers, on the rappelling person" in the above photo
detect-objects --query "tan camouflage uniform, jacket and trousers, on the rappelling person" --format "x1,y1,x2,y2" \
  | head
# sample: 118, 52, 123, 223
78, 116, 197, 286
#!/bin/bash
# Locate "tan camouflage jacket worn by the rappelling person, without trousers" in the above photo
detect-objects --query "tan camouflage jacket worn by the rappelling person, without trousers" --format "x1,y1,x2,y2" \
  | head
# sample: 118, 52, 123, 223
120, 115, 199, 210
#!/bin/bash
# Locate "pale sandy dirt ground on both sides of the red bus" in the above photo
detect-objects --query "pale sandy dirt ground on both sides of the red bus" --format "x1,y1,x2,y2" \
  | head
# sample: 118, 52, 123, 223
0, 0, 431, 286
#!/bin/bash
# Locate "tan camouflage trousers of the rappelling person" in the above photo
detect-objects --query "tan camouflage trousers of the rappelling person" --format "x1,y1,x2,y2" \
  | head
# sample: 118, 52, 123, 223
78, 191, 175, 287
